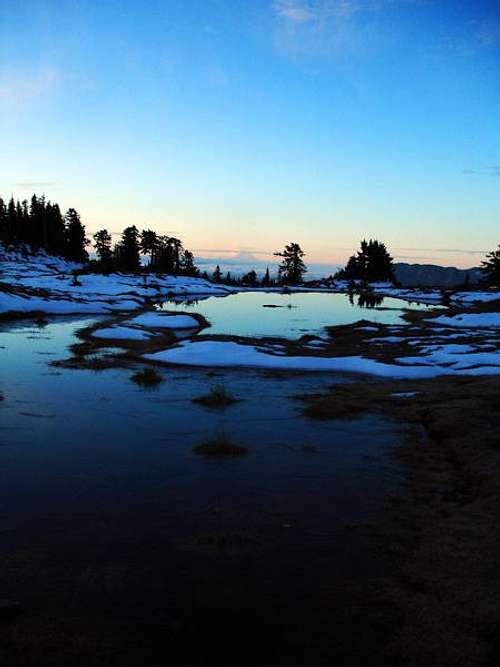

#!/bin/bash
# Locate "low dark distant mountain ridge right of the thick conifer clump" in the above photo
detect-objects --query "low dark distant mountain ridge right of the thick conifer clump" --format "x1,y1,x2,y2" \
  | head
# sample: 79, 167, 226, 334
394, 262, 483, 287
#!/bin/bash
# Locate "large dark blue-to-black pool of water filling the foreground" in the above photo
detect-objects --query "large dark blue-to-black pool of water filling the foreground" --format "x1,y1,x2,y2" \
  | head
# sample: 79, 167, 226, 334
0, 320, 401, 665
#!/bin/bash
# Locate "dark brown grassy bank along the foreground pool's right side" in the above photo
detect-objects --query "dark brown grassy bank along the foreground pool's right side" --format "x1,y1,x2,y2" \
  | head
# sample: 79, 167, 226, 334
305, 378, 500, 667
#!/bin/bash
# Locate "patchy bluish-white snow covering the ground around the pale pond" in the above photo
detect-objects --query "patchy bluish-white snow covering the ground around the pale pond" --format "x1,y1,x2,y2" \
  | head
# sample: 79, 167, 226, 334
0, 246, 500, 379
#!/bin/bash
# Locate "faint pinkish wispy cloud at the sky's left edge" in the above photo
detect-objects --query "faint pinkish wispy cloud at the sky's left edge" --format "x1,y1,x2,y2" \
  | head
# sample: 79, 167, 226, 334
0, 67, 59, 106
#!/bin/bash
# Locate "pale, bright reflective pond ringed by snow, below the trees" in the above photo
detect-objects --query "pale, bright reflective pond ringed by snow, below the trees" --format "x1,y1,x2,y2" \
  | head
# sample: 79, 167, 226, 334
161, 292, 434, 338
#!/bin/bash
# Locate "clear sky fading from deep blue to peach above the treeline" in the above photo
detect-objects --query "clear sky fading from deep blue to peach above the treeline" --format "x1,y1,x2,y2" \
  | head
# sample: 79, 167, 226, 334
0, 0, 500, 270
